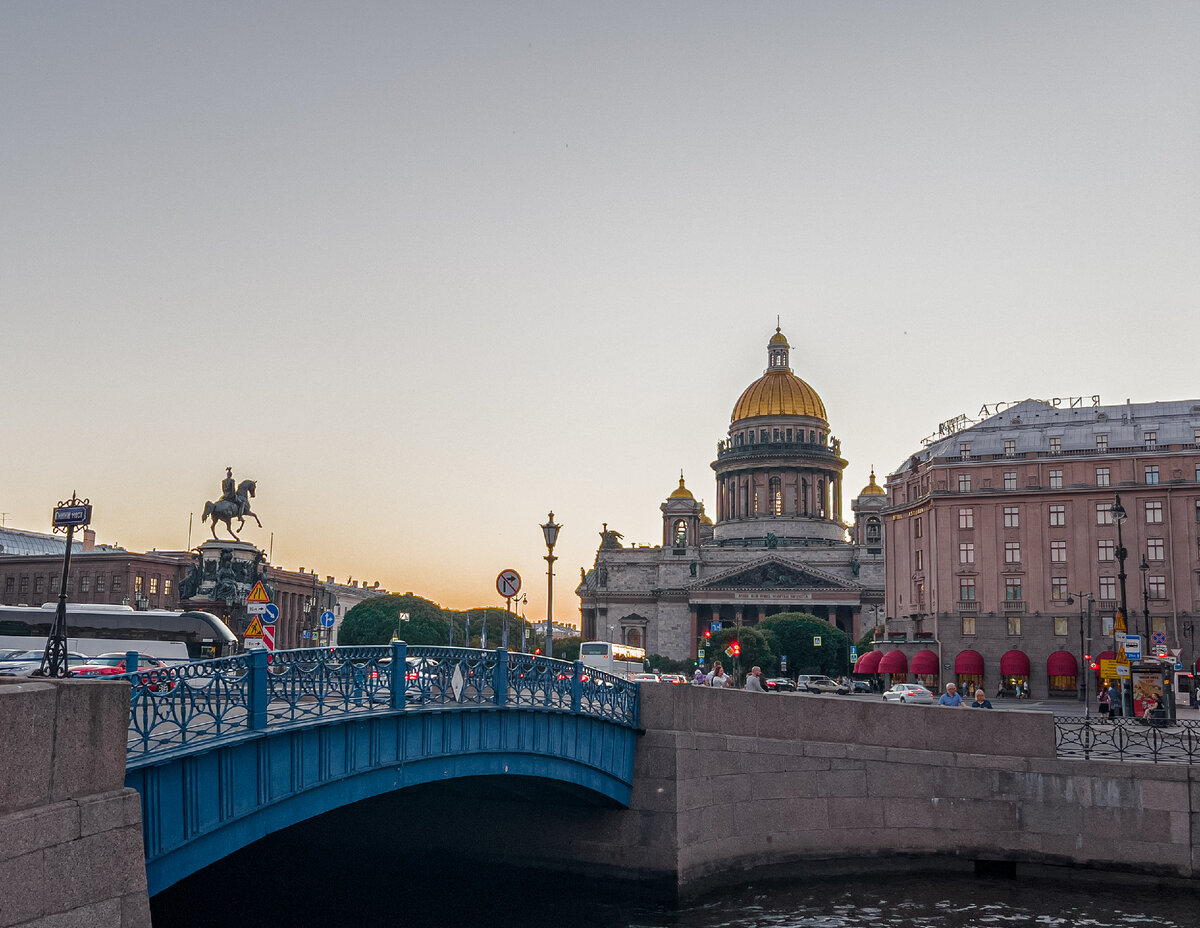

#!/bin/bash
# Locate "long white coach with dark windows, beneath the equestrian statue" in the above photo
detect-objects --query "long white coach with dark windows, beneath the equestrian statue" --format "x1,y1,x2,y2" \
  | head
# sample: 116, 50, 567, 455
0, 603, 238, 660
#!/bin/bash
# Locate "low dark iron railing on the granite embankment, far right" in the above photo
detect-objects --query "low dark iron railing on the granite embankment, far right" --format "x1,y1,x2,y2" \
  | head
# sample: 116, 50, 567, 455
1054, 717, 1200, 764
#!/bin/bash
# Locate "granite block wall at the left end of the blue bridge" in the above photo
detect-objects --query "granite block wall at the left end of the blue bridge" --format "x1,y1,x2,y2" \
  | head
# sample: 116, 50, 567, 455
0, 679, 150, 928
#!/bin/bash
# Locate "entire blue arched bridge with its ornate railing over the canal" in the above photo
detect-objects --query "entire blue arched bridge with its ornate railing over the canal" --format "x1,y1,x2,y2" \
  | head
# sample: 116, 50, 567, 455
124, 642, 638, 896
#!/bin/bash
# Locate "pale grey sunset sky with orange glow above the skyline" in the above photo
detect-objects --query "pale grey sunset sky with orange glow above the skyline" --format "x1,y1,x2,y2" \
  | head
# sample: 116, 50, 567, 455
0, 0, 1200, 621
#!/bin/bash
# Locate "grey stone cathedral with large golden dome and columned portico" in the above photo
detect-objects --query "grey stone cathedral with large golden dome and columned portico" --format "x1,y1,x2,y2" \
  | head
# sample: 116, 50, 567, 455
576, 328, 887, 659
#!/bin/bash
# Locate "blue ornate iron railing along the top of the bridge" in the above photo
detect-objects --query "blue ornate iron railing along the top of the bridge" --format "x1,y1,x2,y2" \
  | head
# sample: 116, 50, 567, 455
118, 641, 638, 767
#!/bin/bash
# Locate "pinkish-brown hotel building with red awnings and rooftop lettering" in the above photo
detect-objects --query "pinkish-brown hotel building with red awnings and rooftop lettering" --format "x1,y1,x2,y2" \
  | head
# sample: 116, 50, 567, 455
866, 397, 1200, 696
